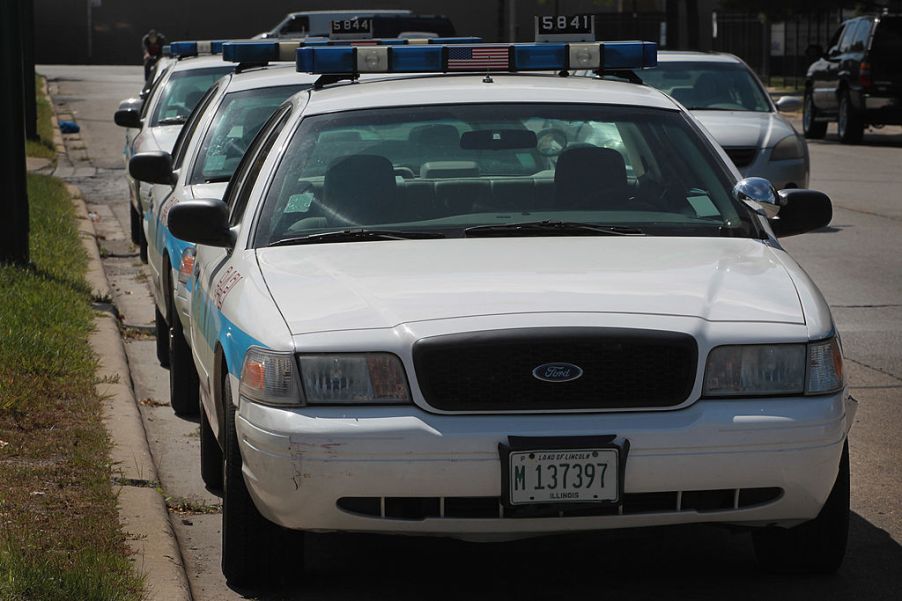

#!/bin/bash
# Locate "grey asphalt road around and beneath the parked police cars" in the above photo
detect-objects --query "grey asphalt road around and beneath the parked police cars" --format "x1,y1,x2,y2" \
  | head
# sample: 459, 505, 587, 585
39, 66, 902, 601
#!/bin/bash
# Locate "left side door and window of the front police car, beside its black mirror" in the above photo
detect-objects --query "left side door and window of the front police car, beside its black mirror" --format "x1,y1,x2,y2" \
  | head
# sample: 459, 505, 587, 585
190, 105, 290, 398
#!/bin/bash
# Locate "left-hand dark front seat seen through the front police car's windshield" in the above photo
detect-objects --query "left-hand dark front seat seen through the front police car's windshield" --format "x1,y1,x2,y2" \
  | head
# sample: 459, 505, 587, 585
321, 154, 398, 226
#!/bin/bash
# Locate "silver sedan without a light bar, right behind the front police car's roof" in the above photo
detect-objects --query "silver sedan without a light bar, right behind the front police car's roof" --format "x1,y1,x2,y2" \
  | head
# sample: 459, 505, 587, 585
641, 52, 810, 189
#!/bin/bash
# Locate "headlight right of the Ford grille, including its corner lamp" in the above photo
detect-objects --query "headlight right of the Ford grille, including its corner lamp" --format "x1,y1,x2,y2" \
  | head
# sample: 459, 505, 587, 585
703, 338, 843, 397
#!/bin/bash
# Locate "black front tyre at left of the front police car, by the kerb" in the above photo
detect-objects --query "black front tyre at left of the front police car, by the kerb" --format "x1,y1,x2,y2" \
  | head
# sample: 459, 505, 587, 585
222, 373, 304, 586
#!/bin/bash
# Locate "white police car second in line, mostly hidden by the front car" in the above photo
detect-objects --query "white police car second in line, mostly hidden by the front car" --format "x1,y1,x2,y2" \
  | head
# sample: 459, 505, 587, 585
129, 43, 322, 415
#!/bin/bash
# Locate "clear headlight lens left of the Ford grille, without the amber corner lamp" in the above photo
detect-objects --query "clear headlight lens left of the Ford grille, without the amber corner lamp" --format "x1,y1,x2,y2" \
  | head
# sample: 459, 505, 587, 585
298, 353, 410, 405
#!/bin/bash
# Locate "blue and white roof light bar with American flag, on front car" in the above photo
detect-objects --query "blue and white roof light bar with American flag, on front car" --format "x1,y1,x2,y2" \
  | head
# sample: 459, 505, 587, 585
297, 42, 658, 75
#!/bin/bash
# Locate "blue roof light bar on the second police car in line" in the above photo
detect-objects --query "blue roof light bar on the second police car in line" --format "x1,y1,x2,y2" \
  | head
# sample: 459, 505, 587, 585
222, 37, 482, 63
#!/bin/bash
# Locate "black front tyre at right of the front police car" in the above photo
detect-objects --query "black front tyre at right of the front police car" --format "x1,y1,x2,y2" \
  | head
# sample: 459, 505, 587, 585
752, 442, 849, 574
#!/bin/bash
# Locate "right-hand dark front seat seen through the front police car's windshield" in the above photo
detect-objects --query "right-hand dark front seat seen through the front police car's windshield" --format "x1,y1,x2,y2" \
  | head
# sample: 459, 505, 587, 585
554, 146, 630, 211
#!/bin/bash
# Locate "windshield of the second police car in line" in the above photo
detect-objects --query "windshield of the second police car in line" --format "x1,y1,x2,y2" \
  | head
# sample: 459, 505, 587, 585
191, 85, 310, 184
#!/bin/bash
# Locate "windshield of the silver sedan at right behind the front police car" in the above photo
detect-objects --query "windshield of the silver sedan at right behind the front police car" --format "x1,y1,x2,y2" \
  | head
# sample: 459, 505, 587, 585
641, 62, 771, 113
